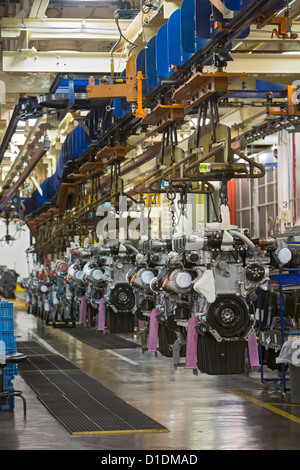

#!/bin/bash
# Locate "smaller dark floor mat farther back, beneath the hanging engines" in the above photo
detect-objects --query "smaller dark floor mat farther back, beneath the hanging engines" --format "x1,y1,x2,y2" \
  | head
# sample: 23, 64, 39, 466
62, 326, 141, 349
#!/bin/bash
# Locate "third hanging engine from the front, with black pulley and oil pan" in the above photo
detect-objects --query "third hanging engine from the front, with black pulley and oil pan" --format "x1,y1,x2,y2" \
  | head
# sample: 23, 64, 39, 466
68, 240, 138, 333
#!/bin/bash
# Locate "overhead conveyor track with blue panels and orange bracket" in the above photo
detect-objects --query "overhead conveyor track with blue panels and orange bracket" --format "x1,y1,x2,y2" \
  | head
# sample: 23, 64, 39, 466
1, 0, 298, 239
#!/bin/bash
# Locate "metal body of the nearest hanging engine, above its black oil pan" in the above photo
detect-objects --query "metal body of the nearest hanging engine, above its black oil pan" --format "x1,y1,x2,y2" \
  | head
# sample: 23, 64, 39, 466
156, 223, 270, 342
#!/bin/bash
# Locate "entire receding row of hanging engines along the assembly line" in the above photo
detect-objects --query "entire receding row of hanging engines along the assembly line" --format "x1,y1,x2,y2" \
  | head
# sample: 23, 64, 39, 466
23, 223, 292, 372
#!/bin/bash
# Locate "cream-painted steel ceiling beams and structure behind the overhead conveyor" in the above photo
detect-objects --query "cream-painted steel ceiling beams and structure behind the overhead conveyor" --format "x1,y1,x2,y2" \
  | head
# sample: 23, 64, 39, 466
0, 0, 300, 206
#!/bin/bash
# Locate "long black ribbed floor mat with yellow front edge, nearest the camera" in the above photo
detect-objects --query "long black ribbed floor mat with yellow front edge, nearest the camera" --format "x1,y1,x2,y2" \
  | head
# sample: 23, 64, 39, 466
17, 341, 169, 435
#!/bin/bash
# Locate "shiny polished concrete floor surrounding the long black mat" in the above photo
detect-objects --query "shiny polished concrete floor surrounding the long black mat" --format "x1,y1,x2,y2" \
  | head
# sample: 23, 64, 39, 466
0, 302, 300, 451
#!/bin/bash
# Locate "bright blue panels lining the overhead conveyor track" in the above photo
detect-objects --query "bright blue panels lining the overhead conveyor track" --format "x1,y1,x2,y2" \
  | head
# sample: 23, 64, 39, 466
19, 0, 284, 215
